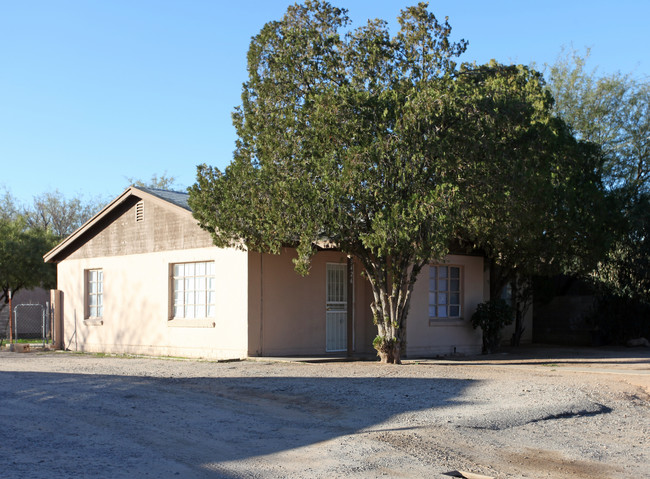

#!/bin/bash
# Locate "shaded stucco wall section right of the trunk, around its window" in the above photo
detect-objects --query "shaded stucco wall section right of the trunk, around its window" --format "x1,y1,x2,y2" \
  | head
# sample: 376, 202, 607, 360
406, 255, 489, 358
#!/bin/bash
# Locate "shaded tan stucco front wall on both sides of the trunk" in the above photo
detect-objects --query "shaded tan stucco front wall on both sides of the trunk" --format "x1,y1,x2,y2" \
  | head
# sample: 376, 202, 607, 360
248, 249, 486, 357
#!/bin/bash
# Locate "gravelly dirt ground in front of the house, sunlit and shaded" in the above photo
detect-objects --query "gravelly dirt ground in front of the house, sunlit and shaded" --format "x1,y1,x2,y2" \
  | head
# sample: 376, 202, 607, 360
0, 348, 650, 479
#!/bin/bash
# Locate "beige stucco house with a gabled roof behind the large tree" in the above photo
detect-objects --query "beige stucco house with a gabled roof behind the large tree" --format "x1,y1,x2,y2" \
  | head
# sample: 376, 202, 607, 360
45, 187, 530, 359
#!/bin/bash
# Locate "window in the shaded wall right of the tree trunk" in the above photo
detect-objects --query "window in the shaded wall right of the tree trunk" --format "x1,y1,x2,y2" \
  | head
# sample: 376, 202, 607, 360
429, 265, 462, 319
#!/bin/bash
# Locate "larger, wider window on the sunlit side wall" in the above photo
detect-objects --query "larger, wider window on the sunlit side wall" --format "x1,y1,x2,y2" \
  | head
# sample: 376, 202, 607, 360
172, 261, 215, 319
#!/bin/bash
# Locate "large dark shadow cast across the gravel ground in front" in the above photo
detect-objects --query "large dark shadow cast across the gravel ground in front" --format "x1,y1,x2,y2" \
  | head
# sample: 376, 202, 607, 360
0, 372, 475, 478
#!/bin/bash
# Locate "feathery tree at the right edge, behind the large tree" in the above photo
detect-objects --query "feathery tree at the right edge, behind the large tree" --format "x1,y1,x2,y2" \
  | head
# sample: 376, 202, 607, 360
549, 50, 650, 340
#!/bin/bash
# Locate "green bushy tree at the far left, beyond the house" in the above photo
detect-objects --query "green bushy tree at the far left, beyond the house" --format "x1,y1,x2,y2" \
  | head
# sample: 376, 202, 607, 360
0, 217, 57, 316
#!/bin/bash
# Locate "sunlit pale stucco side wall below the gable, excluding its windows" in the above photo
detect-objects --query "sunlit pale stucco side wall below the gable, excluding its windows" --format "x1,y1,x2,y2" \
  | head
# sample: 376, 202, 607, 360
57, 248, 248, 359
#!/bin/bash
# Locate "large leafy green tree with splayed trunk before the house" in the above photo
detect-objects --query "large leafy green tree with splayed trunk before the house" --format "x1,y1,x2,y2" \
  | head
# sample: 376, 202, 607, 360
190, 1, 596, 362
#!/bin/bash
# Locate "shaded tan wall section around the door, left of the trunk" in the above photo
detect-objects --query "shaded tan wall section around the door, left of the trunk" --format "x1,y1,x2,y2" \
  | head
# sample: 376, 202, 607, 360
248, 248, 376, 356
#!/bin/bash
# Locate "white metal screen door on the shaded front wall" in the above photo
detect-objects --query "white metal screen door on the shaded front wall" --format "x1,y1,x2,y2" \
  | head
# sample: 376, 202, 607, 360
325, 264, 348, 352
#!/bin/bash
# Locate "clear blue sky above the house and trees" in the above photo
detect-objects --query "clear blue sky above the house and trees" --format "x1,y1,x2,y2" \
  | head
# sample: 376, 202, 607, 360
0, 0, 650, 206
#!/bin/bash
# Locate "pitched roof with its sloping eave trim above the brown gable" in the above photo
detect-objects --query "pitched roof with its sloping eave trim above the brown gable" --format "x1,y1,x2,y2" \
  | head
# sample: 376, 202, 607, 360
43, 186, 192, 263
